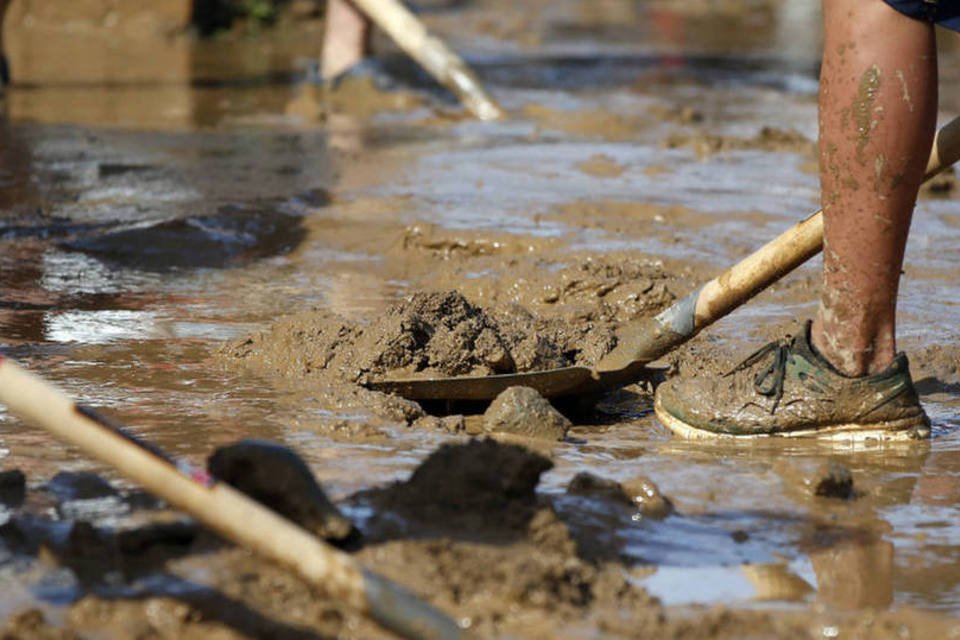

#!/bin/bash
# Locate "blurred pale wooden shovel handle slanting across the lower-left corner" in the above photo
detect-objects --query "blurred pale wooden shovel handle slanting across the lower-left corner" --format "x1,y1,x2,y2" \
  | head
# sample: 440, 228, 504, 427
0, 356, 466, 639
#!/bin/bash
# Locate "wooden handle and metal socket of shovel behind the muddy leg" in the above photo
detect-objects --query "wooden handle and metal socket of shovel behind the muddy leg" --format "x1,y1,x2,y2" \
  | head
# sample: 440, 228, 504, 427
594, 118, 960, 372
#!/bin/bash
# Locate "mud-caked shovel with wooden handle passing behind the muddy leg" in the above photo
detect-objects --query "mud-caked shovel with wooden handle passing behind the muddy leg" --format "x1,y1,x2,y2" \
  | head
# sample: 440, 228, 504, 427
367, 118, 960, 401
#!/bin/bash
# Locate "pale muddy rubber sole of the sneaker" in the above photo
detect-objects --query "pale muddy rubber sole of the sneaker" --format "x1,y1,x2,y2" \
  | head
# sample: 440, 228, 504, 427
653, 395, 930, 442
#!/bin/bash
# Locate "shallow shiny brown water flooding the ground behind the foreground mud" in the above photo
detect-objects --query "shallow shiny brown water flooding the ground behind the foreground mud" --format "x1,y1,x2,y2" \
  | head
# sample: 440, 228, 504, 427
0, 0, 960, 637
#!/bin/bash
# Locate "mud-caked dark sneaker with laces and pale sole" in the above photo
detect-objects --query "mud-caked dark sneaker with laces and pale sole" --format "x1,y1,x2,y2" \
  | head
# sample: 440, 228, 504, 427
654, 322, 930, 440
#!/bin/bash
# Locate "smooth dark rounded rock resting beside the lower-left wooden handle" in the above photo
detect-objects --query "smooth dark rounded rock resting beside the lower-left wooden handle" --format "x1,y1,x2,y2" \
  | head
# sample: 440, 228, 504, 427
207, 440, 356, 541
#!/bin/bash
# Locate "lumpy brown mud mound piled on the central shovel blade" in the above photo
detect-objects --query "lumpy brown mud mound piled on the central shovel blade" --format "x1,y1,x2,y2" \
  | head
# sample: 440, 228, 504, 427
221, 291, 616, 384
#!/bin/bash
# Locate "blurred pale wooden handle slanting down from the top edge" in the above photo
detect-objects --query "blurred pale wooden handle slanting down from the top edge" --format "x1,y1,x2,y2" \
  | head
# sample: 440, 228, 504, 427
352, 0, 503, 120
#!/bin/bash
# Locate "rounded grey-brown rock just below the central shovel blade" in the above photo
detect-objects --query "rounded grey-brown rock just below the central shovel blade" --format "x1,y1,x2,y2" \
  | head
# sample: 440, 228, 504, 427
483, 387, 572, 440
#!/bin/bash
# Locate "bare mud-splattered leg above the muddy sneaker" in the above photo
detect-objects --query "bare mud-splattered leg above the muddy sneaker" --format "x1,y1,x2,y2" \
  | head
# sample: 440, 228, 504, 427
812, 0, 937, 375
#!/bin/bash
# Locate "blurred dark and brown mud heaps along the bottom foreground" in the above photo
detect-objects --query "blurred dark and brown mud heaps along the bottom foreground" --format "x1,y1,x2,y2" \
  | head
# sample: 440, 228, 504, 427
0, 439, 952, 640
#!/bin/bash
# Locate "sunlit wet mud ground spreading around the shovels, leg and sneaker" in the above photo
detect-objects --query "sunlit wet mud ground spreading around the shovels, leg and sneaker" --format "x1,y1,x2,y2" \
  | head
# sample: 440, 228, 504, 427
0, 0, 960, 638
